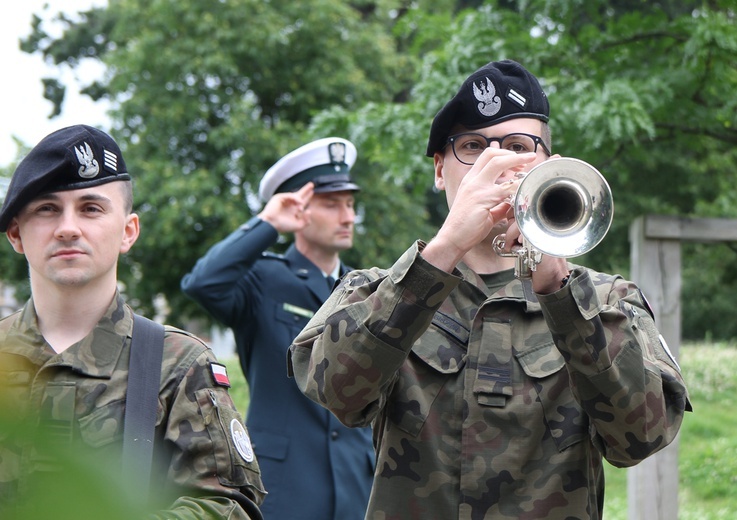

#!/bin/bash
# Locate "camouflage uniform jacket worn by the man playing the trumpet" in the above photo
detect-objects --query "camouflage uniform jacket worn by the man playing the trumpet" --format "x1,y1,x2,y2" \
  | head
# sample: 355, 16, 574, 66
289, 242, 690, 520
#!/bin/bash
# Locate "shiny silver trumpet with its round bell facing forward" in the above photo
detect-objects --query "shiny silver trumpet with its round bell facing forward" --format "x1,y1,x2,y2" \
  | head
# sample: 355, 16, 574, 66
493, 157, 614, 278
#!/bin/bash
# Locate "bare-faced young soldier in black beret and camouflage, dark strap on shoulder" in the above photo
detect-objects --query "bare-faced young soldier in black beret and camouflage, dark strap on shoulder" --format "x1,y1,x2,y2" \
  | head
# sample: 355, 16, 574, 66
0, 125, 264, 519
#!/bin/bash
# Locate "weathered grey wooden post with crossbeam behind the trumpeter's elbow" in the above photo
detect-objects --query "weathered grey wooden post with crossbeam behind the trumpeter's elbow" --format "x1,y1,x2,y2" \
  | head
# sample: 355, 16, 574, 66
627, 215, 737, 520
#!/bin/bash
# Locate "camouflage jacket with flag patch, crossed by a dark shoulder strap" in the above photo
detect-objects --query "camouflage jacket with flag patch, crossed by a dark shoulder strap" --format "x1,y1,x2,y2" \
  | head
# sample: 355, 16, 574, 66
0, 294, 264, 519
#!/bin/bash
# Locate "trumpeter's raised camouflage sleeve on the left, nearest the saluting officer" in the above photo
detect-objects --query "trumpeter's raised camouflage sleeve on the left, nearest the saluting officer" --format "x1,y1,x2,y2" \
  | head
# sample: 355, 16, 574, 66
289, 242, 461, 427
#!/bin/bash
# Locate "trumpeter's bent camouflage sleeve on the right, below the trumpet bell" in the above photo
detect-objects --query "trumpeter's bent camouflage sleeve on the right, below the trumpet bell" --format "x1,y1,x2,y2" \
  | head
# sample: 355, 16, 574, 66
538, 268, 690, 467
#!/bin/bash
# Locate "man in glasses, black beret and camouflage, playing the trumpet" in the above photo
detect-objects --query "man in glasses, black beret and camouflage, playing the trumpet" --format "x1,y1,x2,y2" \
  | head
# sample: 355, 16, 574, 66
289, 60, 689, 520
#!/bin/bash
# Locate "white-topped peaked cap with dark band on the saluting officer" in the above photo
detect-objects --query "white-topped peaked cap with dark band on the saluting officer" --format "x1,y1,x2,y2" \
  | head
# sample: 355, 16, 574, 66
259, 137, 360, 202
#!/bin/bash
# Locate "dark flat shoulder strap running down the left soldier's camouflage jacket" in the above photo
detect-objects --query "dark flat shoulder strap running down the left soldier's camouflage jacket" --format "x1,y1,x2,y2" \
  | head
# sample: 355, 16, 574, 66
123, 314, 164, 501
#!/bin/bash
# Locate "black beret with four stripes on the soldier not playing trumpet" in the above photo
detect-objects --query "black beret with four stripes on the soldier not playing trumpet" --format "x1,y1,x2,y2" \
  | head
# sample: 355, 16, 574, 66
0, 125, 131, 232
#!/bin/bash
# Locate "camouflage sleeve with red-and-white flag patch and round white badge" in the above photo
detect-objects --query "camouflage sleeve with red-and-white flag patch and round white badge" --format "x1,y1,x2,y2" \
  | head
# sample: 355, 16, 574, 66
150, 331, 265, 520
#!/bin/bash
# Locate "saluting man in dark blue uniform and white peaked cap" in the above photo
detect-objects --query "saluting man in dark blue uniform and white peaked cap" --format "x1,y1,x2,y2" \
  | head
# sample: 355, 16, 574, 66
182, 137, 374, 520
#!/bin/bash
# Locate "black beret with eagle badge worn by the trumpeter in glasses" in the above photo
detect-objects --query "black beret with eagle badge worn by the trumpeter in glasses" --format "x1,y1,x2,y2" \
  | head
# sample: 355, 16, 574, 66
426, 60, 550, 157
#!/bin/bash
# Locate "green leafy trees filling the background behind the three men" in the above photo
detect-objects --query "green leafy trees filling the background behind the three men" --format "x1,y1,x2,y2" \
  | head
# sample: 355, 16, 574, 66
1, 0, 737, 337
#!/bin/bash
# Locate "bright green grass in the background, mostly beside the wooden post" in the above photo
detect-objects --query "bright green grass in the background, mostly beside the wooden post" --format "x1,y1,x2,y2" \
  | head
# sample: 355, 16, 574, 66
225, 343, 737, 520
